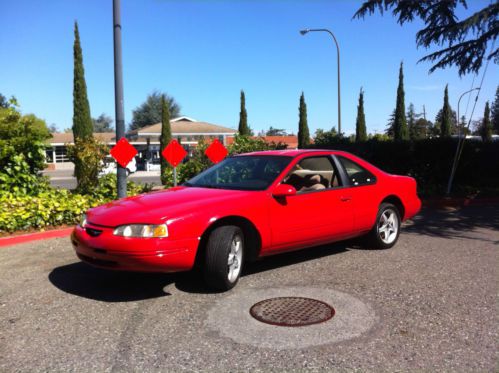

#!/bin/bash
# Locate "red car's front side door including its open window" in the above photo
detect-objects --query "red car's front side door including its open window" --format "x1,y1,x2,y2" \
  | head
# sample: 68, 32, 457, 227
269, 155, 353, 251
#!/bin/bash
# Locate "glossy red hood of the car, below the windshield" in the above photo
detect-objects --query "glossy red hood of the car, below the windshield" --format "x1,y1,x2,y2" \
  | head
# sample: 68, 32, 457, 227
87, 187, 257, 227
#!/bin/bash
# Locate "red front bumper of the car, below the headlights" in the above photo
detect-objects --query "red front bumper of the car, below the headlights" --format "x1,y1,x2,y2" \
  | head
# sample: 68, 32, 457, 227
71, 224, 199, 272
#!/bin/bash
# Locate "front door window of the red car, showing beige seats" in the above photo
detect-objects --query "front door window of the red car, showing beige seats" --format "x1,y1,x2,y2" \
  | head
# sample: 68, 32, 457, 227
283, 156, 341, 193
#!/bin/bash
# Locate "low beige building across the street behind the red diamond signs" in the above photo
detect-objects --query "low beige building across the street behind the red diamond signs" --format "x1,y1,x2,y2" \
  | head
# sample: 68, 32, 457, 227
46, 117, 237, 169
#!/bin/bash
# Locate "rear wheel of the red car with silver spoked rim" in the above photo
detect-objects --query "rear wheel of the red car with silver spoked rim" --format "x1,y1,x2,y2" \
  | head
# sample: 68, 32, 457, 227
367, 203, 401, 249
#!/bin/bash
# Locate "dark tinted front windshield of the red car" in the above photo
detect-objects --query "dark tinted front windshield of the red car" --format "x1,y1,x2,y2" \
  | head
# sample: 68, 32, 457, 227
184, 155, 292, 190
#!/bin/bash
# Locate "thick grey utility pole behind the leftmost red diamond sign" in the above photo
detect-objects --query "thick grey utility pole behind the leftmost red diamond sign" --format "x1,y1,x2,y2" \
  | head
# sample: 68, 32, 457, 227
113, 0, 126, 198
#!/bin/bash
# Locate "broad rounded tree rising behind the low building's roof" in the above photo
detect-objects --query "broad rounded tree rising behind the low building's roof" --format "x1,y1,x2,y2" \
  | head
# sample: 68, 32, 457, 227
130, 91, 180, 130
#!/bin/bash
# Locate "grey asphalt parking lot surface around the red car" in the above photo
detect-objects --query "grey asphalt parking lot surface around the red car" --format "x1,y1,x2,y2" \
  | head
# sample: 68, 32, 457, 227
0, 205, 499, 372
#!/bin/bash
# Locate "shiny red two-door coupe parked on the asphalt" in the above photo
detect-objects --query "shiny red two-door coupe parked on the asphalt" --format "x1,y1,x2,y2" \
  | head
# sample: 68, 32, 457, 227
71, 150, 421, 290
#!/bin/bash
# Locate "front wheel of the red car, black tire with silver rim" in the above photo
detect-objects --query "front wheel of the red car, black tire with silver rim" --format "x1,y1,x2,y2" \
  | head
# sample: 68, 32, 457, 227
203, 225, 244, 291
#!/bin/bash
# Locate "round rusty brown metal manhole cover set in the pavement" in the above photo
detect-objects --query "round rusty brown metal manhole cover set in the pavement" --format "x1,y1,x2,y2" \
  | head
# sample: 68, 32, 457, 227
250, 297, 334, 326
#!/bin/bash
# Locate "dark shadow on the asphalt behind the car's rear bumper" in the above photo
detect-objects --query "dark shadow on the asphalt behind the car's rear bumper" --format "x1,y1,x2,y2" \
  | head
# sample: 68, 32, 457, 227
403, 204, 499, 241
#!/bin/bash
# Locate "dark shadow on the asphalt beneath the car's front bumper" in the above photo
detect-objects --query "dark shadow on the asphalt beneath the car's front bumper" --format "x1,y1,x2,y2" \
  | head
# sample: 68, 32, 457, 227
48, 262, 175, 302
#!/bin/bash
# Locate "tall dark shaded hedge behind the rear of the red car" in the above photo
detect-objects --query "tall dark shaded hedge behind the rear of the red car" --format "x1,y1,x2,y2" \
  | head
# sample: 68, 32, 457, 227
312, 139, 499, 197
